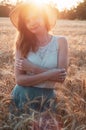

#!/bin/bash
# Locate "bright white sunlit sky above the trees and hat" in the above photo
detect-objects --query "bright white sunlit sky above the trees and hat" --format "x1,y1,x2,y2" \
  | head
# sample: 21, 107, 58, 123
10, 0, 83, 10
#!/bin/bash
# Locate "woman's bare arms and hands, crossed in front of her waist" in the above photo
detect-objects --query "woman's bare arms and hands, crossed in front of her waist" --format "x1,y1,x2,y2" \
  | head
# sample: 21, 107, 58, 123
15, 37, 68, 86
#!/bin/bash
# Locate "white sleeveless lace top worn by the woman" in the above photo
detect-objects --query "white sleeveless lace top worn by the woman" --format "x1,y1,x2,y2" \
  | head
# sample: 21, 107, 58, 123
27, 36, 58, 88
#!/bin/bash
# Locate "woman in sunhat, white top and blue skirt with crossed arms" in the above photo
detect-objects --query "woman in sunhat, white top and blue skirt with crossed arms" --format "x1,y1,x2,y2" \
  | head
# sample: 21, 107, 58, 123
10, 3, 68, 115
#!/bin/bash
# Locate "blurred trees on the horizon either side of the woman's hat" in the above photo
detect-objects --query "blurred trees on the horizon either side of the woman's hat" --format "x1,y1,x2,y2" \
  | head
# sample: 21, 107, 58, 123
0, 0, 86, 20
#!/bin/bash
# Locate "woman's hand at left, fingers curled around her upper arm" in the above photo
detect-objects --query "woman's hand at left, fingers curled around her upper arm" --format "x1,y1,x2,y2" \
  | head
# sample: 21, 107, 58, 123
15, 58, 34, 72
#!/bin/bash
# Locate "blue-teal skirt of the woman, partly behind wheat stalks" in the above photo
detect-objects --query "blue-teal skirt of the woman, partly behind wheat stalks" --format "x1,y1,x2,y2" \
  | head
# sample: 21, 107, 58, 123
10, 85, 57, 113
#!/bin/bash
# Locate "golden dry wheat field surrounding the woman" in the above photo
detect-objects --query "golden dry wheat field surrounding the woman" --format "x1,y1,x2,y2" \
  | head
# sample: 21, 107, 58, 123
0, 18, 86, 130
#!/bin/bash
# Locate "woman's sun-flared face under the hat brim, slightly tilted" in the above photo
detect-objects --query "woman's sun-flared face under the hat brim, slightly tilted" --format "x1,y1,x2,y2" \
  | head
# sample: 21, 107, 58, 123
25, 10, 46, 33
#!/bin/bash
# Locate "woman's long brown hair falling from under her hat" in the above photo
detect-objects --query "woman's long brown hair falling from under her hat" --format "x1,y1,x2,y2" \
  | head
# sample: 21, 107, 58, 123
16, 4, 49, 57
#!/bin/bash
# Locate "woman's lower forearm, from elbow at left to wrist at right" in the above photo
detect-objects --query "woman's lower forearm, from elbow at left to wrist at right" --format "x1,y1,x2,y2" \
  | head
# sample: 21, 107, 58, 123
16, 70, 54, 86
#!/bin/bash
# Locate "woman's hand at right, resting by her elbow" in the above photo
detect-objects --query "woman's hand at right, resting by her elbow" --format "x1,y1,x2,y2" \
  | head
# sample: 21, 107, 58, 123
50, 69, 67, 83
